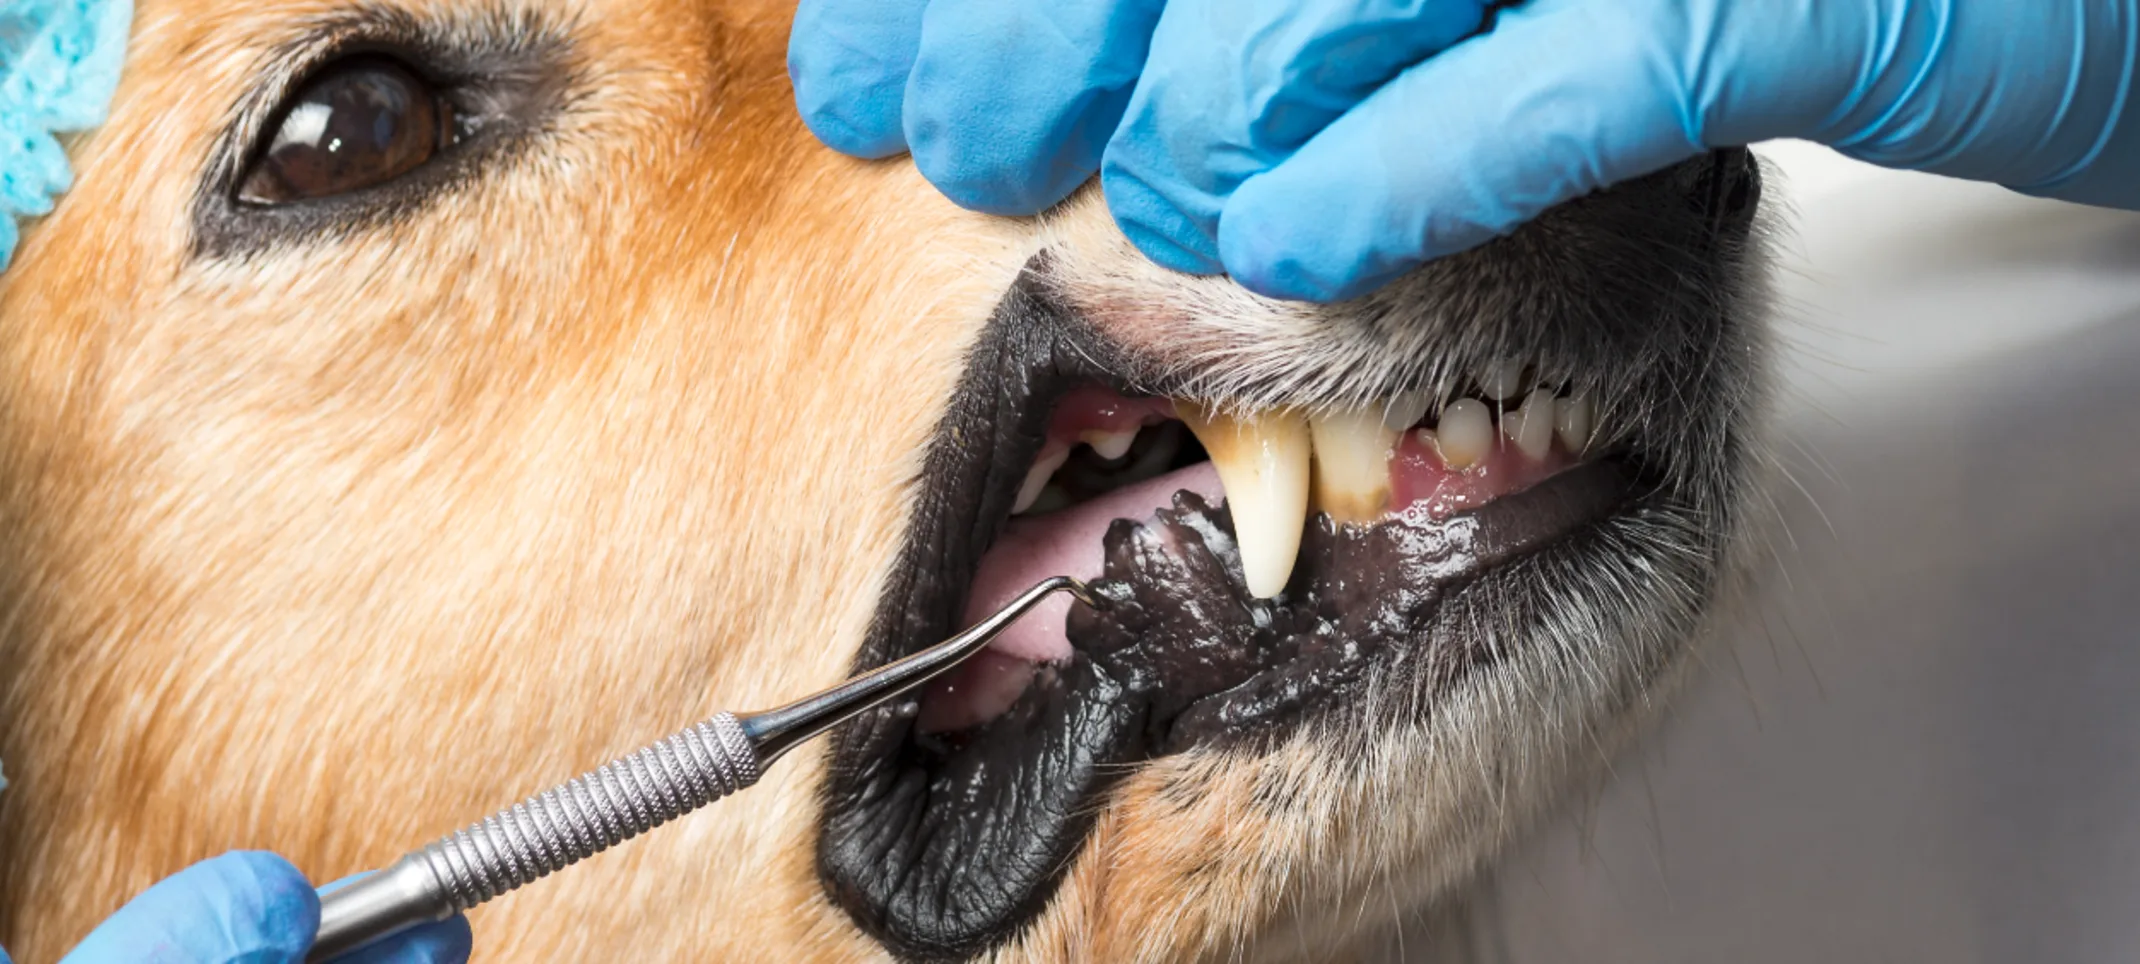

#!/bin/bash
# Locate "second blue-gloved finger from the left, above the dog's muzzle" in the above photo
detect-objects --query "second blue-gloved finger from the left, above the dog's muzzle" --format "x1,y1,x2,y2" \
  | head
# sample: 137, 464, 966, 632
905, 0, 1162, 214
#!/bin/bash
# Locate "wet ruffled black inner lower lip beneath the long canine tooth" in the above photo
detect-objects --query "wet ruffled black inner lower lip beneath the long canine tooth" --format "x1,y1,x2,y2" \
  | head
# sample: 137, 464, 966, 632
1070, 461, 1631, 754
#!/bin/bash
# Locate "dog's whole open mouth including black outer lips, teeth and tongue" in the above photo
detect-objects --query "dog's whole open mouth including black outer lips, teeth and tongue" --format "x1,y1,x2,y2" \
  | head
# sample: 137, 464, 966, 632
817, 151, 1731, 958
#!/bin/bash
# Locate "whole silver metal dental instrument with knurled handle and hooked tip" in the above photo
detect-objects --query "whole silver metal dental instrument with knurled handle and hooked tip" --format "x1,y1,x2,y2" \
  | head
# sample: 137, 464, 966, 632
304, 576, 1098, 962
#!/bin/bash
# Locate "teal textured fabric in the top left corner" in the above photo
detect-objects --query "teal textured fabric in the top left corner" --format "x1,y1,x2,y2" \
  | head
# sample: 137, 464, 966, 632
0, 0, 133, 270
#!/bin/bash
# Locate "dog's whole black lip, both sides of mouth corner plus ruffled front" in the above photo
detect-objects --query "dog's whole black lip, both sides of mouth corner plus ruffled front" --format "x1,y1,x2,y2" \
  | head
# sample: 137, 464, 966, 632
817, 263, 1626, 955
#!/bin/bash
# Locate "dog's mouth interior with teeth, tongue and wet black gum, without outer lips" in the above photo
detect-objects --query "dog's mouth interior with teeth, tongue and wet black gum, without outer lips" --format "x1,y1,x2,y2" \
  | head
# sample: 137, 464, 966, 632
912, 372, 1633, 741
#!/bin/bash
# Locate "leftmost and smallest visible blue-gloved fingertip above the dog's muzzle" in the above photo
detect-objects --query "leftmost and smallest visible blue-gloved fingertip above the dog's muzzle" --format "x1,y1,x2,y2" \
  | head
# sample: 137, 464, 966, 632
788, 0, 929, 156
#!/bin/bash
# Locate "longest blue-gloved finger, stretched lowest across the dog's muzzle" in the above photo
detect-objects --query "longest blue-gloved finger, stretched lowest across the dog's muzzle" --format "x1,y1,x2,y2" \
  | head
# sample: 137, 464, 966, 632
1218, 0, 1706, 300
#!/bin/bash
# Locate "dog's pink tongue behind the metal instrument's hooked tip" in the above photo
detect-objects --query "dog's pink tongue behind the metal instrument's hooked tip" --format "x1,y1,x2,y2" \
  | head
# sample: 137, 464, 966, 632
959, 463, 1224, 662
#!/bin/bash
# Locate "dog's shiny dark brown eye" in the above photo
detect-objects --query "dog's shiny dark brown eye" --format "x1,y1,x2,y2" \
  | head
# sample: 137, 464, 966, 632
238, 58, 454, 204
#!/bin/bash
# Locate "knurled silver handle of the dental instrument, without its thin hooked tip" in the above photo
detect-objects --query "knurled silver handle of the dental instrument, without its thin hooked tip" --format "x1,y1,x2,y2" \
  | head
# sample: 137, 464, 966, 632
306, 713, 760, 962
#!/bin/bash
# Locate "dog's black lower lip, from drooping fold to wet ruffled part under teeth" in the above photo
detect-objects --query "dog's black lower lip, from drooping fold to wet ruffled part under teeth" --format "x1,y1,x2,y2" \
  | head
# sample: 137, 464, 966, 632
820, 465, 1629, 960
